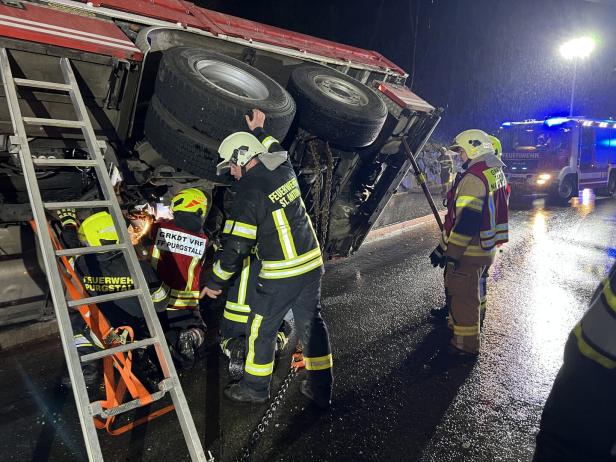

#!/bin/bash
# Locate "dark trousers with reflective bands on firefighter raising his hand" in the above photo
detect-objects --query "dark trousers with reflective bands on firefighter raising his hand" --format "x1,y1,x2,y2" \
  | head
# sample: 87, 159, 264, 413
242, 268, 333, 392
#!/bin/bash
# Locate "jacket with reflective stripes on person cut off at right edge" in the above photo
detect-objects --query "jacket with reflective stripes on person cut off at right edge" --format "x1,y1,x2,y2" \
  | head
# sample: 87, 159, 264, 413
573, 264, 616, 369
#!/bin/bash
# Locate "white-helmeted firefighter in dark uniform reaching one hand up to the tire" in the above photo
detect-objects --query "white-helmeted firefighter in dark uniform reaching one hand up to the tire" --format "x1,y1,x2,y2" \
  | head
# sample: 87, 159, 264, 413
201, 109, 333, 408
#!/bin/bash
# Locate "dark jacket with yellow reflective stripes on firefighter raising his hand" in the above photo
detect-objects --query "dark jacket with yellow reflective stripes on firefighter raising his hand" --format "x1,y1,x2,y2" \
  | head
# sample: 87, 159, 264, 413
206, 129, 323, 288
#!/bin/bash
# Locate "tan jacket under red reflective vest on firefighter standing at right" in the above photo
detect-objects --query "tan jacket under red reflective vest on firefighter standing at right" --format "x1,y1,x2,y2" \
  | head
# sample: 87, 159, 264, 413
441, 154, 509, 265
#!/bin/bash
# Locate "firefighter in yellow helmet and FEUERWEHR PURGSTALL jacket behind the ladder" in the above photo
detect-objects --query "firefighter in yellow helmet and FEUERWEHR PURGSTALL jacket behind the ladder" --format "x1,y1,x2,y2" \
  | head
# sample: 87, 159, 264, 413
57, 209, 165, 386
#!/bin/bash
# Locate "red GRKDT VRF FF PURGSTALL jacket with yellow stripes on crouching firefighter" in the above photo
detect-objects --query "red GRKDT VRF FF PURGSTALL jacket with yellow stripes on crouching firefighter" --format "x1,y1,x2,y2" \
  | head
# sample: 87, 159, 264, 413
150, 221, 208, 309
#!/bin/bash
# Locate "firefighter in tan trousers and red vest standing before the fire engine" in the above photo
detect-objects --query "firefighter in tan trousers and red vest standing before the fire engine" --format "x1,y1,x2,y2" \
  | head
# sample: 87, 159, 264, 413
430, 130, 509, 355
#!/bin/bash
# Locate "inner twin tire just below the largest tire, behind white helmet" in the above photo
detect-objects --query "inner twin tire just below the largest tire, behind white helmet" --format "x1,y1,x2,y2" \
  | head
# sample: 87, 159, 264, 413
144, 96, 220, 181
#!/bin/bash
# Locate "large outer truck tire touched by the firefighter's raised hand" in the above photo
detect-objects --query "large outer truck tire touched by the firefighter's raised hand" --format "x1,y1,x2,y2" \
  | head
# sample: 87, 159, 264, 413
155, 47, 295, 141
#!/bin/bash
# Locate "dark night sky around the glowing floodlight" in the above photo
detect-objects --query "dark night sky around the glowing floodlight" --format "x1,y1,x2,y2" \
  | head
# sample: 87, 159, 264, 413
198, 0, 616, 140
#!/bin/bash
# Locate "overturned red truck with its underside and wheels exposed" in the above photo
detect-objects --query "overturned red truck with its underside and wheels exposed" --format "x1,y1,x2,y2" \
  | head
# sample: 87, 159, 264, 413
0, 0, 440, 326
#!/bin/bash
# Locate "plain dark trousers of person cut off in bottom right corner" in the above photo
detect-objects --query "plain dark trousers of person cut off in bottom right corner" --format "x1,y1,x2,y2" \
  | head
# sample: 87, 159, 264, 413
533, 334, 616, 462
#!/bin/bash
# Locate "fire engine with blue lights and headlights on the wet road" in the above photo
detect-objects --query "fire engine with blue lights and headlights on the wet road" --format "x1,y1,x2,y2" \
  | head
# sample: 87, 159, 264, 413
500, 117, 616, 201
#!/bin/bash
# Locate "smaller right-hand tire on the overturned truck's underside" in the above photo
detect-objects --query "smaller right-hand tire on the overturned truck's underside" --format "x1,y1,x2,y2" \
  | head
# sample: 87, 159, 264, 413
287, 64, 387, 148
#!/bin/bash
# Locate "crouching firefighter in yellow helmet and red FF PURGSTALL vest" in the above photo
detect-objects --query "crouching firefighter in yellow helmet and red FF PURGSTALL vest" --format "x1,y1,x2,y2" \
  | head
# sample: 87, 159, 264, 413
149, 188, 208, 368
